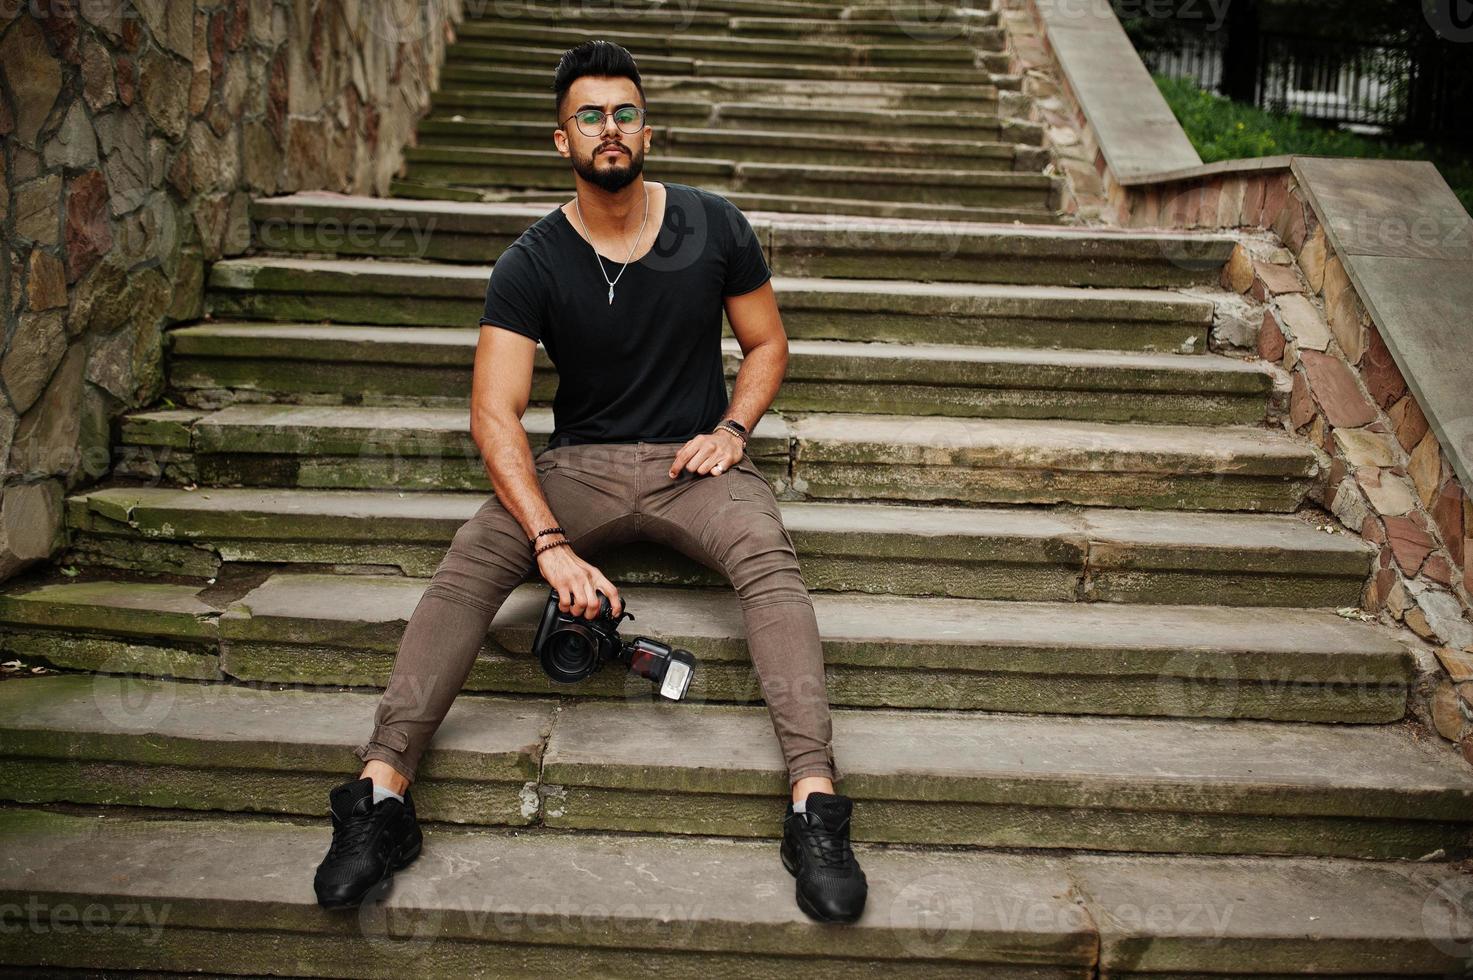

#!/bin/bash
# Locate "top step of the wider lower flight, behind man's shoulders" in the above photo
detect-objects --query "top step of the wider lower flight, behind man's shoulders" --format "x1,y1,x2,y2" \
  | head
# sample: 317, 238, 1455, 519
250, 192, 1234, 289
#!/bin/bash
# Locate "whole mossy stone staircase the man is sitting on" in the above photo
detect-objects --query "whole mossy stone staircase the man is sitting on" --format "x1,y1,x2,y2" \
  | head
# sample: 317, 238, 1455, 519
0, 0, 1473, 979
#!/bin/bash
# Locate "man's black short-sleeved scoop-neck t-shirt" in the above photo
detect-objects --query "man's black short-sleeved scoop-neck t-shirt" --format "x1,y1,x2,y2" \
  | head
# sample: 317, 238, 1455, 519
480, 181, 772, 447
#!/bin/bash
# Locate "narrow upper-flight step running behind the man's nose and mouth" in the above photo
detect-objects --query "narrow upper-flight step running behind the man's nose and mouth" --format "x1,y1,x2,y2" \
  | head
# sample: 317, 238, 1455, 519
418, 119, 1022, 172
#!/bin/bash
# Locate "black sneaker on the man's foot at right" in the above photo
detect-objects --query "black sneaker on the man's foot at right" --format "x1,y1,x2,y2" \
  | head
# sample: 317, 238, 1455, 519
782, 793, 869, 923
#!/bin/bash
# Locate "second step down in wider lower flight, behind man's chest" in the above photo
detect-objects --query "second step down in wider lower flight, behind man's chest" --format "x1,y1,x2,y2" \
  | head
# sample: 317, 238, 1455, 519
206, 256, 1214, 352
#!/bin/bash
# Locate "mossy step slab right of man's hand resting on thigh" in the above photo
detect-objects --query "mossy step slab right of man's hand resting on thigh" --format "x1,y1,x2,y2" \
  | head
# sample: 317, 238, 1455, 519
790, 413, 1323, 511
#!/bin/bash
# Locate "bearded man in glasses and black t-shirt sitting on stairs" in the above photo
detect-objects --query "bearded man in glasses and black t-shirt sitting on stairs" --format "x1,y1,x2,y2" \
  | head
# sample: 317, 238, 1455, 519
315, 41, 868, 923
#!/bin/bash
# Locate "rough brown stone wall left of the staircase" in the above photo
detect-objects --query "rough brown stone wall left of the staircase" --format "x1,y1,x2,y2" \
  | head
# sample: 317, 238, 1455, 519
0, 0, 461, 579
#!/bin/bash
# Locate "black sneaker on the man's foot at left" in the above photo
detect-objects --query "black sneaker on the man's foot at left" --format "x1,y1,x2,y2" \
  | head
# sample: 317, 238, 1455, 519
312, 777, 423, 909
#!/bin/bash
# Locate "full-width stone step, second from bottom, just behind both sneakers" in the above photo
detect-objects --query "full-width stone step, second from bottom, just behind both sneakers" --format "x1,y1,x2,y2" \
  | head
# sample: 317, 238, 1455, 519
0, 675, 1473, 859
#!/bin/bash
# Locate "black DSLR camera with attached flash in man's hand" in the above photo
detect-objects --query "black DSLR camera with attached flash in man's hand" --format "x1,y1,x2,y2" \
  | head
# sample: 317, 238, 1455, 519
532, 589, 695, 701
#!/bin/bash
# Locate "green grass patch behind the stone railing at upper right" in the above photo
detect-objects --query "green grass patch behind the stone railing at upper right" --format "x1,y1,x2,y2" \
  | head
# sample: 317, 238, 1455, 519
1155, 75, 1473, 211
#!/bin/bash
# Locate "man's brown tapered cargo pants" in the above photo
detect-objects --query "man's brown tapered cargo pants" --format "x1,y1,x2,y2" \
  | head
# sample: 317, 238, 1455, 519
355, 442, 837, 784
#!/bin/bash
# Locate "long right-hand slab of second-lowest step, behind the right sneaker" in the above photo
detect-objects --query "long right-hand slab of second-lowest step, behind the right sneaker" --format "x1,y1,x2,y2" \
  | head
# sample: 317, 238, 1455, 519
542, 701, 1473, 858
